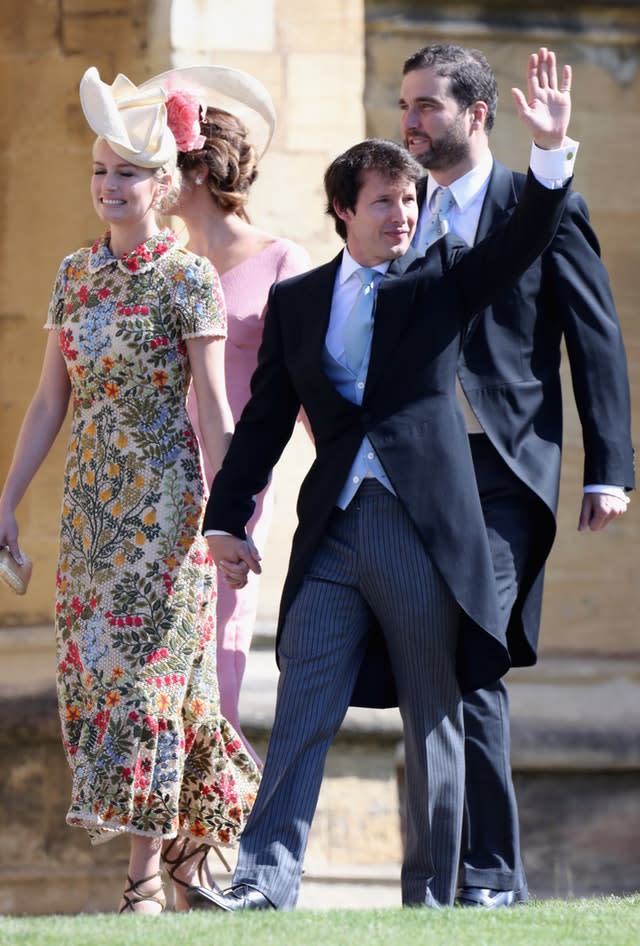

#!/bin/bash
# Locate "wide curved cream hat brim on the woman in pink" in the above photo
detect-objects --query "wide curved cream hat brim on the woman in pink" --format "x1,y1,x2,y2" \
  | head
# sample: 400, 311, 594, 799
139, 66, 276, 157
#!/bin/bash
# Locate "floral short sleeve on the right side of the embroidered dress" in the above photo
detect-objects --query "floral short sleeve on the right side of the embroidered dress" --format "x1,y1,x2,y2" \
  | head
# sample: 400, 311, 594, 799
178, 253, 227, 338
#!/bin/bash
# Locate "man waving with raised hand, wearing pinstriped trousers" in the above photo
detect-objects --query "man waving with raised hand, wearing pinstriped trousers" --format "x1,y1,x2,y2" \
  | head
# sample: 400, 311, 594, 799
187, 50, 575, 911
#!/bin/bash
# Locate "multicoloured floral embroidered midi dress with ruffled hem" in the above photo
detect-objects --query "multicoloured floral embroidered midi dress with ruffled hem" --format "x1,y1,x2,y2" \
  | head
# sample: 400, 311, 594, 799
46, 230, 259, 845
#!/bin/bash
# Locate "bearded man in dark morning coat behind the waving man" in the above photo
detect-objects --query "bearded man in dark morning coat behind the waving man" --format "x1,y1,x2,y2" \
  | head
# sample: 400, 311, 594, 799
400, 45, 634, 908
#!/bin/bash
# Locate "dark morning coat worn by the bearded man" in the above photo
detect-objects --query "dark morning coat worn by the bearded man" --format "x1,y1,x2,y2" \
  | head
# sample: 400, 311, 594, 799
418, 168, 635, 666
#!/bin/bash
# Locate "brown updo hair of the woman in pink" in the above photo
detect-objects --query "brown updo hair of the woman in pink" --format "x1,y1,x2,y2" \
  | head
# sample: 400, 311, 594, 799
178, 107, 258, 223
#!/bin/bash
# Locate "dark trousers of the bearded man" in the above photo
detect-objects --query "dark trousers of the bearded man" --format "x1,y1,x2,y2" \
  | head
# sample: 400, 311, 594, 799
461, 434, 538, 899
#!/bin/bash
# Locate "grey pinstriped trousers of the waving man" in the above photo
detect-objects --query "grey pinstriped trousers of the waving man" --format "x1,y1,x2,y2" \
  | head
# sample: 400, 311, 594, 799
234, 481, 464, 909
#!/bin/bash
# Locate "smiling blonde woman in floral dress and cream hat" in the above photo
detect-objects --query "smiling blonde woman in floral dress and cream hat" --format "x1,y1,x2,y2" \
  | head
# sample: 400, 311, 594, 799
0, 69, 259, 913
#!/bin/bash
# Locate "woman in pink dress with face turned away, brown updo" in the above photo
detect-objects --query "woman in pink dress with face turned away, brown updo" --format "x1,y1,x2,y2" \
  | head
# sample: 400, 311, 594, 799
145, 66, 310, 763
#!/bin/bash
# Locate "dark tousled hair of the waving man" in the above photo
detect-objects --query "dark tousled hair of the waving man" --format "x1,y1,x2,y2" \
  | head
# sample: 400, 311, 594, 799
324, 138, 424, 240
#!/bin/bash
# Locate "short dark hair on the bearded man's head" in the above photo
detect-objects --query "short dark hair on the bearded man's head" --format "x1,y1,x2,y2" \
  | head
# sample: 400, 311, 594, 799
402, 44, 498, 134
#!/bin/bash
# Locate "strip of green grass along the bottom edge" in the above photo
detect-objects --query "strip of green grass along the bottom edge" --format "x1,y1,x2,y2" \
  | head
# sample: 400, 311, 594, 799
0, 895, 640, 946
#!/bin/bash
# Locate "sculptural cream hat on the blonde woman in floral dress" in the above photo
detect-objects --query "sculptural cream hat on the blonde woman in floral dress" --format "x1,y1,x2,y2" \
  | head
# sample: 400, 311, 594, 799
80, 66, 176, 168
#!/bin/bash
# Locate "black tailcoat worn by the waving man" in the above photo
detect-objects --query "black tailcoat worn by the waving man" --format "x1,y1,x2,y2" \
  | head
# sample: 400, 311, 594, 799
203, 173, 569, 706
